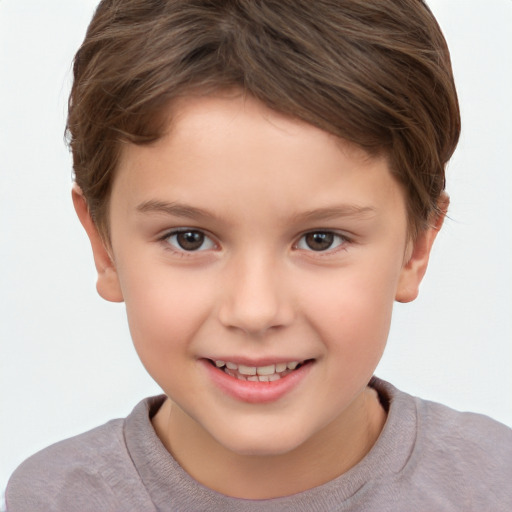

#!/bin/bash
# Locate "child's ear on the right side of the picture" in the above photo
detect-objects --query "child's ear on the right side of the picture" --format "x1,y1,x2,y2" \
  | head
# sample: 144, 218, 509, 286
395, 193, 450, 302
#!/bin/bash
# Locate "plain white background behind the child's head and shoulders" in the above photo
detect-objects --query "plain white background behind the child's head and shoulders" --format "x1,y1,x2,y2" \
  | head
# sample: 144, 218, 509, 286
0, 0, 512, 488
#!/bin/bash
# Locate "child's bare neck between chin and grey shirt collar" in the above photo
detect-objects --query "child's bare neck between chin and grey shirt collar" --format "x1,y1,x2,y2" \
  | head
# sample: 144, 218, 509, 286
153, 388, 386, 499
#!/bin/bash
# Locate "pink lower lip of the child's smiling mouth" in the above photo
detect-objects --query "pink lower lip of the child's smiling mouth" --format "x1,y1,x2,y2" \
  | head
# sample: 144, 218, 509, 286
200, 359, 313, 404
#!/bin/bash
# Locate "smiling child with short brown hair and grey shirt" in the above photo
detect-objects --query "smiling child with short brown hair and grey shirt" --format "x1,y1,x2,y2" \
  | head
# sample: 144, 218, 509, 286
6, 0, 512, 512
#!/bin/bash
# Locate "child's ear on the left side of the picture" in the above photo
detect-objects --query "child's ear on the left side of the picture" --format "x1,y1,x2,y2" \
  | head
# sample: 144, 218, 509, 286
71, 183, 123, 302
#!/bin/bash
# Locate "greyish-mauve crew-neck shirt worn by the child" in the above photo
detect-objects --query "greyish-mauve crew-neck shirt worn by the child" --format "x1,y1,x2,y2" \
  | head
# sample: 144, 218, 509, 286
6, 379, 512, 512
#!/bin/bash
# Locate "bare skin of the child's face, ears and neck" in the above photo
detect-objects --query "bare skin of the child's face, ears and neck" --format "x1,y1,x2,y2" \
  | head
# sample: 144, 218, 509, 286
73, 94, 442, 499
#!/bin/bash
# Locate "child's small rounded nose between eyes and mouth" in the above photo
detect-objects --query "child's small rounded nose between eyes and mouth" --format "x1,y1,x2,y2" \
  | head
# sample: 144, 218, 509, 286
219, 252, 294, 336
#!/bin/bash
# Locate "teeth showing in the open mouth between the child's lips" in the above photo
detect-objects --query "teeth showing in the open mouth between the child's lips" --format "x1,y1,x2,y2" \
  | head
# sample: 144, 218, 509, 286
208, 359, 313, 382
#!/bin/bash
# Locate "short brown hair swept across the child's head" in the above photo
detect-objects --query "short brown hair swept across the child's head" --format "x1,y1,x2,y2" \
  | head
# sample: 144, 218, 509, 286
67, 0, 460, 238
